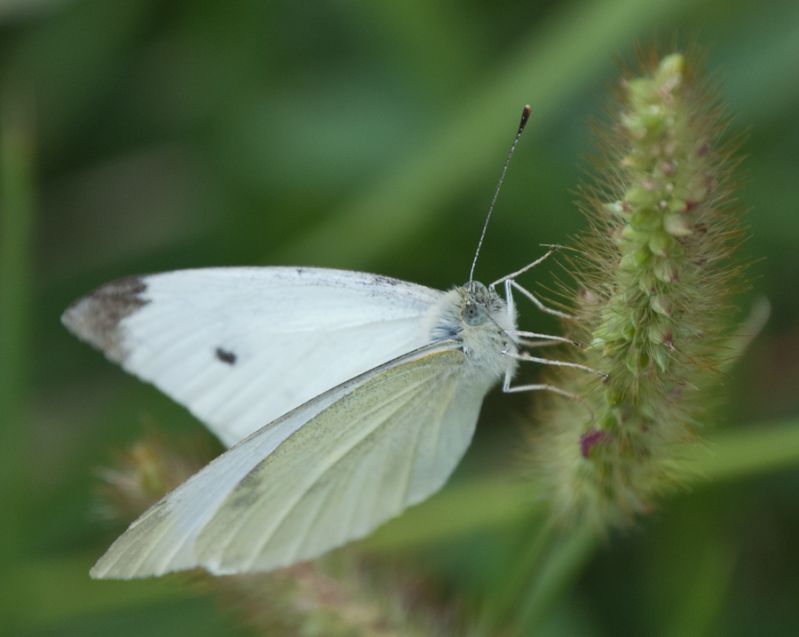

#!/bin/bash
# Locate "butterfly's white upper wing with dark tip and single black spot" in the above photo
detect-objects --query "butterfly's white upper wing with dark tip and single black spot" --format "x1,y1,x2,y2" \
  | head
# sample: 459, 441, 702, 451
62, 267, 442, 446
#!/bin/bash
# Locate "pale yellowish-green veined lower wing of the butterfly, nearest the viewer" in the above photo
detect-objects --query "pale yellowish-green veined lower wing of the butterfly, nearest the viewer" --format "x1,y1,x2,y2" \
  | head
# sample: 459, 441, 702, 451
92, 341, 488, 578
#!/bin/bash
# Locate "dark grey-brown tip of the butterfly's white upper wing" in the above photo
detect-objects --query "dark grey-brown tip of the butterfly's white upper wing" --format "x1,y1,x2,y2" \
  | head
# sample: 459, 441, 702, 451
61, 277, 149, 362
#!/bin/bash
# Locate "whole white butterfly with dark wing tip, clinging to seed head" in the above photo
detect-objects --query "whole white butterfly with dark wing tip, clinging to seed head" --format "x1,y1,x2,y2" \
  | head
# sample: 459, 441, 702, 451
62, 111, 592, 579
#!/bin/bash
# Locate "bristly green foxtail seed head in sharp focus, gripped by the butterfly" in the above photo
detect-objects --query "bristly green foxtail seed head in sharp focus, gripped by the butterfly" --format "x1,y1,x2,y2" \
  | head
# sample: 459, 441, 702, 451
531, 53, 741, 529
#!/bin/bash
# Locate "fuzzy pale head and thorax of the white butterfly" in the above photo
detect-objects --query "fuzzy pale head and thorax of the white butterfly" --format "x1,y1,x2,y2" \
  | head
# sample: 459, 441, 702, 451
425, 281, 516, 384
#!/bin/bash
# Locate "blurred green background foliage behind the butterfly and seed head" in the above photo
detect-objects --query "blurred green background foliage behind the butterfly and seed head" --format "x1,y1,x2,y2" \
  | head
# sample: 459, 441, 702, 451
0, 0, 799, 637
